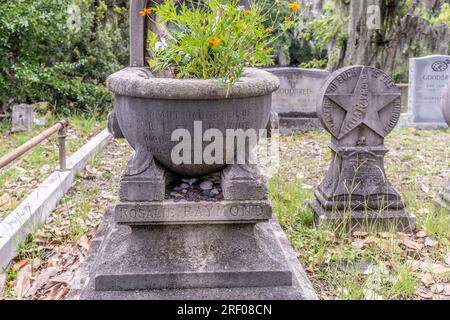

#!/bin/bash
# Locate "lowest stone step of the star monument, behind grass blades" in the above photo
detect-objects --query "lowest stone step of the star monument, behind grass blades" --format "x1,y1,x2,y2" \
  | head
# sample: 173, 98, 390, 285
311, 200, 416, 232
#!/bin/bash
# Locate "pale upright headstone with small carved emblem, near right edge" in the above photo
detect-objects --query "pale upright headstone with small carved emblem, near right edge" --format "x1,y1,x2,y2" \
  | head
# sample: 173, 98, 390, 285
402, 55, 450, 129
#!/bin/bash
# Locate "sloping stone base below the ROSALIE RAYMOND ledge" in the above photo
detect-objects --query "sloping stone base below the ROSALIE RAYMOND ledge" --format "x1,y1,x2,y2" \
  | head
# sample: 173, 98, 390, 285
68, 210, 317, 300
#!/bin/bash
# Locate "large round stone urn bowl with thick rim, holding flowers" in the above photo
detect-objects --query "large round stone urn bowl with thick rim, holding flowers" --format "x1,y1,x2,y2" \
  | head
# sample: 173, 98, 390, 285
107, 67, 279, 176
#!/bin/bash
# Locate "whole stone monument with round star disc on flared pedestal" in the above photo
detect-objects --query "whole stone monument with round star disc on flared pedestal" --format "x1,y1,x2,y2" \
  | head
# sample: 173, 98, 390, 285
313, 66, 415, 231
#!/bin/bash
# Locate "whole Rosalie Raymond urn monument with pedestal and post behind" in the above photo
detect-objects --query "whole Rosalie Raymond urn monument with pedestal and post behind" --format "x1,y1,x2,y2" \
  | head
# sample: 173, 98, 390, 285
71, 1, 315, 299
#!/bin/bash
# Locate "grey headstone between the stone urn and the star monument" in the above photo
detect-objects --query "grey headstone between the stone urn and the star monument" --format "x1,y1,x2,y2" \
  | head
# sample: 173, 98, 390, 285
265, 67, 329, 134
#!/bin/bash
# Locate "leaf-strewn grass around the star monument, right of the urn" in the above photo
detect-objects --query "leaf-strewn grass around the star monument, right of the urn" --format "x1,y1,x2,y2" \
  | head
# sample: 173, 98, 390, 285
269, 129, 450, 300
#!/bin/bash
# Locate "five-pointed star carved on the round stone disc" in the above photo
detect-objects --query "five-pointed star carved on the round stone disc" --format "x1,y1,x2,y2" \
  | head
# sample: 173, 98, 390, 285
325, 67, 400, 139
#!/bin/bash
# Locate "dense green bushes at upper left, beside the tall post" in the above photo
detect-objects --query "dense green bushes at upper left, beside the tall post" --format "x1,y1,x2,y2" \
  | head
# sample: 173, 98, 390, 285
0, 0, 127, 113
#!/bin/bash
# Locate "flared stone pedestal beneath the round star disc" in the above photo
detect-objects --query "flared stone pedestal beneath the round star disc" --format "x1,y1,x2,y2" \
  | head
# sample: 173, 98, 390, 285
312, 144, 416, 231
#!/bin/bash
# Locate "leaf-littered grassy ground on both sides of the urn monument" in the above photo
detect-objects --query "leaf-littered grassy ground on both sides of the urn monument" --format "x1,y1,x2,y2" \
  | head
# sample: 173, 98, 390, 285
0, 123, 450, 300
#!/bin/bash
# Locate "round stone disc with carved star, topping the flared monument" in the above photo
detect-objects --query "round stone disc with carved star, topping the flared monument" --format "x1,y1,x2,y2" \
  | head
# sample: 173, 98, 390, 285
317, 66, 401, 140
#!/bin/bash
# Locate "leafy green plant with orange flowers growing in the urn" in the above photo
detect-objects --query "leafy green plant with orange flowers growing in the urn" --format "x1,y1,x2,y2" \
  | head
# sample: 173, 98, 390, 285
141, 0, 299, 89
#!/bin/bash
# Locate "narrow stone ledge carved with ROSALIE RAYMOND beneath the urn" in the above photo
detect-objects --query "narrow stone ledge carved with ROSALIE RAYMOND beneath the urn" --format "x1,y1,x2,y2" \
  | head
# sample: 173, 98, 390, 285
115, 200, 272, 225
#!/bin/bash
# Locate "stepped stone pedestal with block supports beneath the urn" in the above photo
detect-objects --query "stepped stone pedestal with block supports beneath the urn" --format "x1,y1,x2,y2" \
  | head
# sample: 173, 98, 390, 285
72, 162, 315, 299
